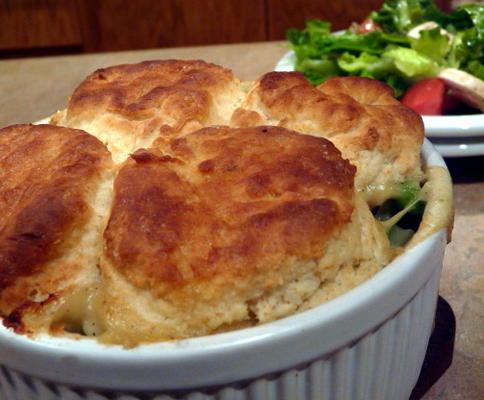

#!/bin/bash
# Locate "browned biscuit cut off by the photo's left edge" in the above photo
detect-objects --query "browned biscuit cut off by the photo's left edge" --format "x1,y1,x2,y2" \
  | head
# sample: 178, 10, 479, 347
0, 125, 111, 331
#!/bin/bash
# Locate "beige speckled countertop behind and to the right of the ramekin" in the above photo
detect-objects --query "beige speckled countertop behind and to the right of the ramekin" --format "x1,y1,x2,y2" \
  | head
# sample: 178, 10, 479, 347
0, 42, 484, 400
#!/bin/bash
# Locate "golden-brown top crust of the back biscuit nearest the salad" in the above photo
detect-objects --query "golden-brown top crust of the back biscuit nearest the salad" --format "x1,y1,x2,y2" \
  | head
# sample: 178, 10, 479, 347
247, 72, 422, 141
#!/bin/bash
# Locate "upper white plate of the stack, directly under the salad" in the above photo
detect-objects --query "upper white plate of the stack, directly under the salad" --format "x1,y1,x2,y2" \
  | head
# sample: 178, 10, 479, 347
274, 51, 484, 141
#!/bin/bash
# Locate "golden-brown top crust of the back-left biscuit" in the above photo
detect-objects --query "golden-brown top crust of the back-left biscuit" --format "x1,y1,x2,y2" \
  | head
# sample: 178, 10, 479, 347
68, 60, 234, 120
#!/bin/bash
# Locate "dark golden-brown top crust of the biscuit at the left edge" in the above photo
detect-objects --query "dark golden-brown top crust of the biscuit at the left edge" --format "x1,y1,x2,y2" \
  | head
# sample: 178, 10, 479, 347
0, 125, 110, 290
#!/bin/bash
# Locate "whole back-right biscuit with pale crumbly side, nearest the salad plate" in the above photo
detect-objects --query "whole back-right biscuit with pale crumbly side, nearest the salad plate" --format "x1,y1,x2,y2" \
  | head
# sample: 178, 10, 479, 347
231, 72, 423, 203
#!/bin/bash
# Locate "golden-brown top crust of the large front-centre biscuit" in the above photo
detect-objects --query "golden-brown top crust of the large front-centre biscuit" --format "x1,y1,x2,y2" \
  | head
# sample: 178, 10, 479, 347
105, 127, 355, 296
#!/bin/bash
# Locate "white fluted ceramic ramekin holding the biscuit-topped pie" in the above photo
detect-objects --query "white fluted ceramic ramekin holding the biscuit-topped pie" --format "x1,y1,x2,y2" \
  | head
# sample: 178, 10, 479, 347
0, 141, 446, 400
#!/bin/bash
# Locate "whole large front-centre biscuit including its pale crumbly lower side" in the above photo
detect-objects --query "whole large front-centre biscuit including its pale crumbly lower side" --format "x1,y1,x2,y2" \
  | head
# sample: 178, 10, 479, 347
100, 127, 391, 345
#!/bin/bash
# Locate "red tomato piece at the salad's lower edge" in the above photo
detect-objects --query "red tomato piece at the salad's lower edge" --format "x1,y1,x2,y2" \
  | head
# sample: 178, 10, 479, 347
401, 78, 445, 115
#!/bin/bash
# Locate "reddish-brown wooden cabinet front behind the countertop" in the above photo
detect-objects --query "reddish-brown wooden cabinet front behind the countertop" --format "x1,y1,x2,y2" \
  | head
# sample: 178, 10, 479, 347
0, 0, 449, 59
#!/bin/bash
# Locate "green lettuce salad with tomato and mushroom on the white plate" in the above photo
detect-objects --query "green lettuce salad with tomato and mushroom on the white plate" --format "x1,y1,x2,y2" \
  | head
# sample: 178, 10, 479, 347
287, 0, 484, 115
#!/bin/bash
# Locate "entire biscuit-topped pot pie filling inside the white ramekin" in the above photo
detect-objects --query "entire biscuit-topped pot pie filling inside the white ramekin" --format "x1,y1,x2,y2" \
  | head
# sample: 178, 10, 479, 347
0, 60, 451, 347
